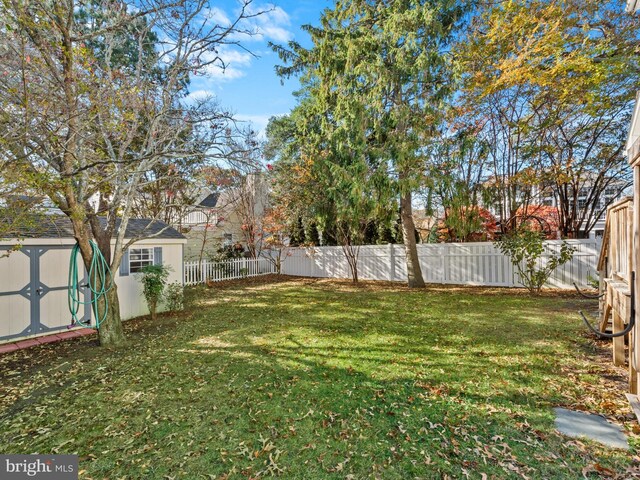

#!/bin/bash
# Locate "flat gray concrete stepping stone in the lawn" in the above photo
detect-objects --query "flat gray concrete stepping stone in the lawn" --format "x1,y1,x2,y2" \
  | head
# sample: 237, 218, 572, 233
553, 408, 629, 450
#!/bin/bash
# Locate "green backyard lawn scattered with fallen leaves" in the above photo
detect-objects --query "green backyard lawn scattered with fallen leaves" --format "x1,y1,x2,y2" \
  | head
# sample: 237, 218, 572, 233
0, 279, 638, 480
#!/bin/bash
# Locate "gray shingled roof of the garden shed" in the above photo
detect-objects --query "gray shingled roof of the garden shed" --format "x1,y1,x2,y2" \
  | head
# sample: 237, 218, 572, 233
15, 215, 185, 239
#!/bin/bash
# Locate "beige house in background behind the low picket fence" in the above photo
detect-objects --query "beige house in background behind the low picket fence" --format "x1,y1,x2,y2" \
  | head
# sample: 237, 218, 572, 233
176, 173, 269, 260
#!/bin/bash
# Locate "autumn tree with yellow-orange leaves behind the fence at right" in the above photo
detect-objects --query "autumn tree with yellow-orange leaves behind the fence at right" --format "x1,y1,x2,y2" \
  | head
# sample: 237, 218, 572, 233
455, 0, 640, 237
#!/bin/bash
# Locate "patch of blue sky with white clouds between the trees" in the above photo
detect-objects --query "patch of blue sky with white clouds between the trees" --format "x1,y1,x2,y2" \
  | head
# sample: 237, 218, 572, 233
190, 0, 333, 132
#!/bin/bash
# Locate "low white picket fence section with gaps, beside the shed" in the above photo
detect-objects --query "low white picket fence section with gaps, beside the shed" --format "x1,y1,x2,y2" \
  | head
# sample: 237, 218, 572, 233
184, 258, 276, 285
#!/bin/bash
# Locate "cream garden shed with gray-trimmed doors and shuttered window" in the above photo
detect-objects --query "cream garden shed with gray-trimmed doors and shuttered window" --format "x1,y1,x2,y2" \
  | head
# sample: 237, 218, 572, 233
0, 215, 187, 343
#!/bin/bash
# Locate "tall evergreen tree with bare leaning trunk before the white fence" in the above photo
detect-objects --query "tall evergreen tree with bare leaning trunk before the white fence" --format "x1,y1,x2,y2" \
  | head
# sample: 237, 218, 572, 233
275, 0, 463, 287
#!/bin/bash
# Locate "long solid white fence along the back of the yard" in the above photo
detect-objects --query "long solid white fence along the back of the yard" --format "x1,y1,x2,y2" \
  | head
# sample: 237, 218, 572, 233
281, 240, 600, 288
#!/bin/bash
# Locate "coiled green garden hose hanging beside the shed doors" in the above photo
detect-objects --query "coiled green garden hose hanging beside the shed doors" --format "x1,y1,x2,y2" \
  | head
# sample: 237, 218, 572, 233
68, 240, 113, 329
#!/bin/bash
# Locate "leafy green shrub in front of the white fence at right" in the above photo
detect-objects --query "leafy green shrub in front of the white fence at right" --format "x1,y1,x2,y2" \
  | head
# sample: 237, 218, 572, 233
495, 228, 575, 294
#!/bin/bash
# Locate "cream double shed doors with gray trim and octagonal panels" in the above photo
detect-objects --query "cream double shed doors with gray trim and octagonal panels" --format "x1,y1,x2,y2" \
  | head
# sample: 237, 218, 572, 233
0, 245, 90, 342
